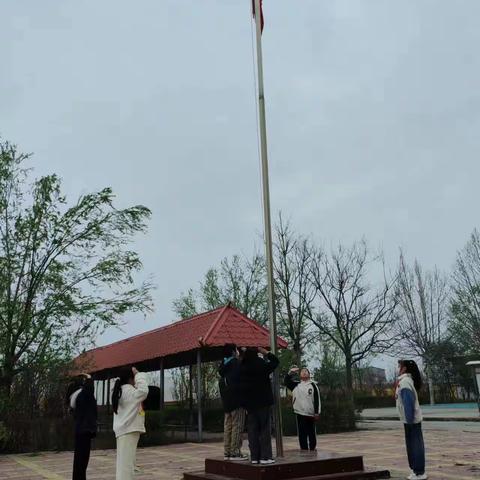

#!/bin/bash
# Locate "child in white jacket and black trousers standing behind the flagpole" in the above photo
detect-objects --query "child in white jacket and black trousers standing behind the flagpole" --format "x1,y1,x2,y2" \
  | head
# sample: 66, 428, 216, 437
285, 367, 321, 452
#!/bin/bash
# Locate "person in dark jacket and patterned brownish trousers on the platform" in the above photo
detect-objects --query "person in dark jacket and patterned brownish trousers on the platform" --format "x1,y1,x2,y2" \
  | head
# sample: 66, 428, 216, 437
218, 343, 248, 461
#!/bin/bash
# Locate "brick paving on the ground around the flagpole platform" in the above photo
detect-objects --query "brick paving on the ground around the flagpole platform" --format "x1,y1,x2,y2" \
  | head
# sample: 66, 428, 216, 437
0, 429, 480, 480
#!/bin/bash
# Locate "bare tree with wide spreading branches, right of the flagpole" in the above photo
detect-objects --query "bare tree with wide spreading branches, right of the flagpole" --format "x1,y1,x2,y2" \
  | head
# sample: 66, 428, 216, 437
309, 241, 397, 404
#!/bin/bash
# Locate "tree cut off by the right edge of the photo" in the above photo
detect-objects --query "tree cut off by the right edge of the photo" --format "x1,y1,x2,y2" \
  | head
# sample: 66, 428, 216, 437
450, 229, 480, 353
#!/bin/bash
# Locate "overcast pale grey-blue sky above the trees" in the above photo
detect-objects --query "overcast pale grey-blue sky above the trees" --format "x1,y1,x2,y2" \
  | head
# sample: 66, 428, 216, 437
0, 0, 480, 356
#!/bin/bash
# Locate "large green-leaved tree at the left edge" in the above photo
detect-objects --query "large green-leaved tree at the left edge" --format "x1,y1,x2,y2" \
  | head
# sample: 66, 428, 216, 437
0, 142, 151, 395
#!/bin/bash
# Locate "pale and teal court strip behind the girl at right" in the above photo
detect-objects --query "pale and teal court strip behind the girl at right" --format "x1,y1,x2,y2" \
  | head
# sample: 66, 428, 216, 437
362, 403, 480, 421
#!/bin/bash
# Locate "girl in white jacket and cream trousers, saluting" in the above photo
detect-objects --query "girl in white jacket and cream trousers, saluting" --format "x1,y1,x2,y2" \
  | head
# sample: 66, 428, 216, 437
112, 367, 148, 480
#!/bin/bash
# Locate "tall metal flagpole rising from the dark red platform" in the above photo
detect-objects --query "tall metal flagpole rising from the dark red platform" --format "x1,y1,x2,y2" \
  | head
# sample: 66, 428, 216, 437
254, 0, 283, 457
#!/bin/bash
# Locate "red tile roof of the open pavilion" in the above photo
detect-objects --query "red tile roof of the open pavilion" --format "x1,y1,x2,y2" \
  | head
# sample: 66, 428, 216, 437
75, 305, 287, 373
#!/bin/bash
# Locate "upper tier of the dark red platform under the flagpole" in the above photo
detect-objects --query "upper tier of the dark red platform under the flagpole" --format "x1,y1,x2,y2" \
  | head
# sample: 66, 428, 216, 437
205, 451, 364, 480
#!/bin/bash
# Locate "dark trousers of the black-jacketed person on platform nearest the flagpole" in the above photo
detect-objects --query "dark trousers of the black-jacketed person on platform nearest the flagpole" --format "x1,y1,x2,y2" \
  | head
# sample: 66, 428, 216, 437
248, 407, 273, 462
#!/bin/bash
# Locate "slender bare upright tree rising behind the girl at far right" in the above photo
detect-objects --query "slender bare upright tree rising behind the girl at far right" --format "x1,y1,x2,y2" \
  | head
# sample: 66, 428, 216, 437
396, 254, 449, 405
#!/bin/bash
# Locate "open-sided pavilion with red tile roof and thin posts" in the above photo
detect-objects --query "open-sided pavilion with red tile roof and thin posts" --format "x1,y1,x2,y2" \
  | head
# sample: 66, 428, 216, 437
74, 304, 288, 441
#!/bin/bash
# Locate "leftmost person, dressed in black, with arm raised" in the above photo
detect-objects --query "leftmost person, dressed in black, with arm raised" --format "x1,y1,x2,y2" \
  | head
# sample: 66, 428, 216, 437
67, 374, 97, 480
